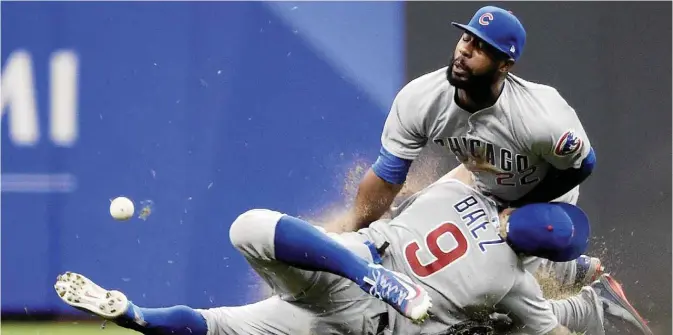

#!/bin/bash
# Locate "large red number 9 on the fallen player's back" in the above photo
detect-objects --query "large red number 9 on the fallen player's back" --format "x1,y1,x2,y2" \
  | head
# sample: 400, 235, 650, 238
404, 222, 468, 278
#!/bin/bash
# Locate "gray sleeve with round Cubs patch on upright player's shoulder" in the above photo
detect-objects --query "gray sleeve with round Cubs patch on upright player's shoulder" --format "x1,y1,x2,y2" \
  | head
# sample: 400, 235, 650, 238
533, 96, 591, 170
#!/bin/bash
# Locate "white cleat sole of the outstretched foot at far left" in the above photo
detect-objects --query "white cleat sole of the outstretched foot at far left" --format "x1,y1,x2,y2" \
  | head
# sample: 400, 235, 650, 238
54, 272, 129, 320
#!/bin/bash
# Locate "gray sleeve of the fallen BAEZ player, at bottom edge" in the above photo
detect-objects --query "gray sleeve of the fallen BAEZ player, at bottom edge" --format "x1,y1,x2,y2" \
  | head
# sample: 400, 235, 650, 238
498, 271, 558, 335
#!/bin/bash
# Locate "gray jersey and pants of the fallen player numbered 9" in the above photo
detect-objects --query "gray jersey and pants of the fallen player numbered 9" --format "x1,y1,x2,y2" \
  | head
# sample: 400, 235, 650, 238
198, 179, 602, 335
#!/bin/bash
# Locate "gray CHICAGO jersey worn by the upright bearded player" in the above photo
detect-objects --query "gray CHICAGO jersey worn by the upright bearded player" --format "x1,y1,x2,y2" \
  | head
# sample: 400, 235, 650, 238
381, 68, 591, 201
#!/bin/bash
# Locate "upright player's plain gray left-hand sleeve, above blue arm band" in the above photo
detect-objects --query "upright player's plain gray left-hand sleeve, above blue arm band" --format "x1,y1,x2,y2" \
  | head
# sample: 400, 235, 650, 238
381, 82, 427, 160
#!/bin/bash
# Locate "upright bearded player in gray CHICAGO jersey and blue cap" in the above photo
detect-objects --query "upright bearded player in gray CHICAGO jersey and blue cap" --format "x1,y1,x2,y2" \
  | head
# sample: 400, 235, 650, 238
329, 6, 602, 298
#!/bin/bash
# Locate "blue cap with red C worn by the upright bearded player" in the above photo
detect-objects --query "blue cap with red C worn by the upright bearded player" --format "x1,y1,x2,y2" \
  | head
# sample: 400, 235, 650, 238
451, 6, 526, 61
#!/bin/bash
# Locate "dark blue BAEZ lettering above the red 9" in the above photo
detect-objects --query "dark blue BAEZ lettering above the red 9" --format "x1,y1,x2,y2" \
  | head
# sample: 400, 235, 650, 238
453, 196, 505, 253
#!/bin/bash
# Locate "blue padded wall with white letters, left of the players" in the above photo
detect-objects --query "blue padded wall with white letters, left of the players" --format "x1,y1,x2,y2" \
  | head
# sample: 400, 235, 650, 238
1, 2, 404, 313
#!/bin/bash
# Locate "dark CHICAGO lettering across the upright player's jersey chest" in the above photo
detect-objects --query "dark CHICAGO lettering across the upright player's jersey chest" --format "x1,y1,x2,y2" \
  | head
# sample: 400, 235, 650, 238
434, 136, 540, 186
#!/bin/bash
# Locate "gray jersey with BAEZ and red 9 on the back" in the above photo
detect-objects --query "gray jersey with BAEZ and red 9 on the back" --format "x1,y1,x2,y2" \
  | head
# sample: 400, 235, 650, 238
361, 180, 558, 334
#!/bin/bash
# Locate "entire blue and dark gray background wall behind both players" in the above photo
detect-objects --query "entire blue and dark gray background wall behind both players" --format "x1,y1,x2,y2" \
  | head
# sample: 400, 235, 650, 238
1, 2, 671, 334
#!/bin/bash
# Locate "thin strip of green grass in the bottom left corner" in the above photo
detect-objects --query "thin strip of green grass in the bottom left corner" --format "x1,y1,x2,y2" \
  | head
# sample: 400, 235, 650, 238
0, 321, 139, 335
